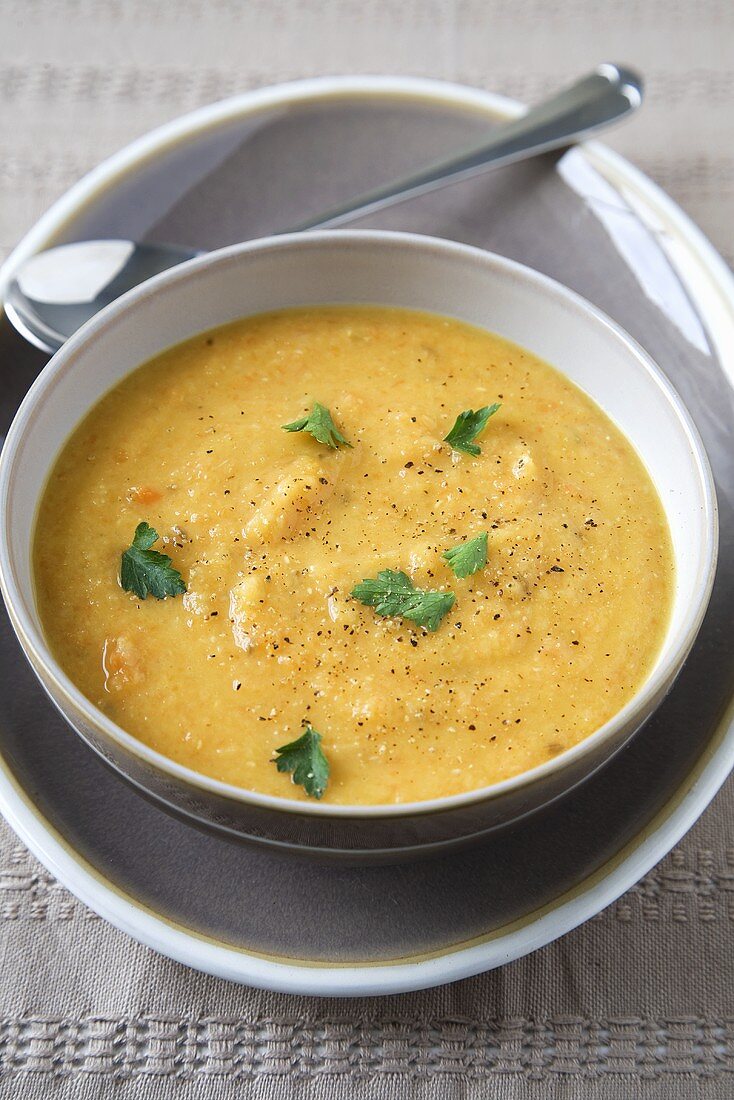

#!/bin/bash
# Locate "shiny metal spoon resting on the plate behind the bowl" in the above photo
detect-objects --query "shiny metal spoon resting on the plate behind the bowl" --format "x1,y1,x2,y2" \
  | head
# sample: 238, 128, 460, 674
3, 64, 643, 353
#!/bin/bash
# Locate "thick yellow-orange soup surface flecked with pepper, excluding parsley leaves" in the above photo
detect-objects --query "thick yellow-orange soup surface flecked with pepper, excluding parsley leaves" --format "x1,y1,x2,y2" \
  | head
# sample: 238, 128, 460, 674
35, 307, 672, 804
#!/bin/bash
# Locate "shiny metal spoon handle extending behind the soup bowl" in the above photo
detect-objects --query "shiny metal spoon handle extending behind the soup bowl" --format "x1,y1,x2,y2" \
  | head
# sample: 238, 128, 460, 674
288, 63, 644, 232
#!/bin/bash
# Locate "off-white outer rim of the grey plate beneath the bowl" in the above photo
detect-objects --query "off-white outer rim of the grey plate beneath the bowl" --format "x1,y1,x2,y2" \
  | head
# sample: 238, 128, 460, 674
0, 76, 734, 997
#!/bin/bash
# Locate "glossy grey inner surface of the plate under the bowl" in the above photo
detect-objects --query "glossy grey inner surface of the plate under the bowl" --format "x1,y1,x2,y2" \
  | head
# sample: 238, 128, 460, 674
0, 81, 734, 989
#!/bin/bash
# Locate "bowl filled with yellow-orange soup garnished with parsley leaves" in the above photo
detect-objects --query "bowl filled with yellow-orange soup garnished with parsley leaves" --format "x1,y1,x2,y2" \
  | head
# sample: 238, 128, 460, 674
0, 232, 716, 859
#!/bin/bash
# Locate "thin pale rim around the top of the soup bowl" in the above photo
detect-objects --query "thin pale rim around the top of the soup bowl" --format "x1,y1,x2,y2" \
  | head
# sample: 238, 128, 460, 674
0, 229, 719, 820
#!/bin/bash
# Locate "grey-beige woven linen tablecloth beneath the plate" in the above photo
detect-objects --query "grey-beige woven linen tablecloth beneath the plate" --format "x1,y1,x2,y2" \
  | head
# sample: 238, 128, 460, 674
0, 0, 734, 1100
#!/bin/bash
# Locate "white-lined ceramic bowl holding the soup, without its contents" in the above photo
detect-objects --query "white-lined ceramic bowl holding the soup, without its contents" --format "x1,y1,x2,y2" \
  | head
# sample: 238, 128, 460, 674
0, 232, 716, 859
